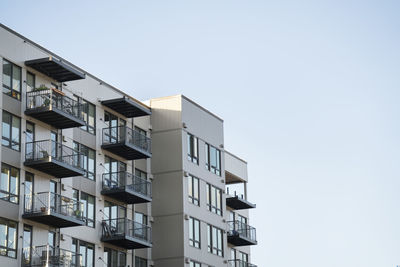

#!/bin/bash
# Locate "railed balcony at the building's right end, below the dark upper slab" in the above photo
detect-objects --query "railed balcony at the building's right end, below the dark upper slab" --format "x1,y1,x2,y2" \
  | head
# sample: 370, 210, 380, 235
228, 221, 257, 247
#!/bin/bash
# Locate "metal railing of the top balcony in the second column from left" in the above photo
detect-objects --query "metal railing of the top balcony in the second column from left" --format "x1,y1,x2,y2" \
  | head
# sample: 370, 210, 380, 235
103, 126, 151, 153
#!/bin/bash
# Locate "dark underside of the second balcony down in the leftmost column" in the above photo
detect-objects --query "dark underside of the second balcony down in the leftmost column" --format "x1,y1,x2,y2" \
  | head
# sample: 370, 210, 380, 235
24, 158, 85, 178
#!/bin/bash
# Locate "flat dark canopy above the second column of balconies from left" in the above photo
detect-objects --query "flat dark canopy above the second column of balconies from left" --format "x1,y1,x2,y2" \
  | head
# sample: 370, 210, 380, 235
101, 97, 151, 118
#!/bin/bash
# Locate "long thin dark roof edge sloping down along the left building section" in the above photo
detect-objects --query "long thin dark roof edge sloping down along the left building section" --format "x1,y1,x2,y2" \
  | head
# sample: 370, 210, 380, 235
0, 23, 151, 109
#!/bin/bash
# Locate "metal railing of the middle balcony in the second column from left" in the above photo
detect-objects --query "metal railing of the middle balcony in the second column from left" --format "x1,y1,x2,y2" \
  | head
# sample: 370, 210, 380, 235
103, 171, 151, 197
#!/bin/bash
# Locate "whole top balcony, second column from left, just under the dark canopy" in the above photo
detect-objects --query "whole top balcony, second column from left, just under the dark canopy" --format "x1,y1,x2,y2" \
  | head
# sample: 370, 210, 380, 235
101, 126, 151, 160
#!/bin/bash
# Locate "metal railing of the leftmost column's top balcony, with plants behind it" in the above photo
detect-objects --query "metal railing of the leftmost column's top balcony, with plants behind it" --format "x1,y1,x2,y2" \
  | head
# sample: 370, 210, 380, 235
26, 89, 87, 120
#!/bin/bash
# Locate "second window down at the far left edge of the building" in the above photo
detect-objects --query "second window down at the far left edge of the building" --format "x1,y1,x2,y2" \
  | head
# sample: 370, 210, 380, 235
2, 110, 21, 151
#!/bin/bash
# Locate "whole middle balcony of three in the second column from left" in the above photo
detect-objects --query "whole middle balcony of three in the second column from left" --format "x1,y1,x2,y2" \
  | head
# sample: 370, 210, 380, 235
101, 171, 151, 204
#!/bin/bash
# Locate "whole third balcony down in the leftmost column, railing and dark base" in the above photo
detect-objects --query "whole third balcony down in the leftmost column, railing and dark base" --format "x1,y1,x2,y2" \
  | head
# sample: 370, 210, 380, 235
22, 192, 85, 228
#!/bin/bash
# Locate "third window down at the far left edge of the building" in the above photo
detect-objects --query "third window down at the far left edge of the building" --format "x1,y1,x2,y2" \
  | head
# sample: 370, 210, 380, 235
0, 163, 19, 204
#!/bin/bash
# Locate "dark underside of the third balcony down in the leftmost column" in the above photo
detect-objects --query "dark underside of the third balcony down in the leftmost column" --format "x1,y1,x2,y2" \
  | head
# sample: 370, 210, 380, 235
22, 211, 85, 228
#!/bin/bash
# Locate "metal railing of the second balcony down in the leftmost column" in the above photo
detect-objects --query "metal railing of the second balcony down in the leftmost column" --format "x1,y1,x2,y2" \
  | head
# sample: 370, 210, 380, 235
25, 140, 84, 169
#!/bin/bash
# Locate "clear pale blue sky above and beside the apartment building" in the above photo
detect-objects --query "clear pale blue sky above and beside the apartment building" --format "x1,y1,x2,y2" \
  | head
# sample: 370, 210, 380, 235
0, 0, 400, 267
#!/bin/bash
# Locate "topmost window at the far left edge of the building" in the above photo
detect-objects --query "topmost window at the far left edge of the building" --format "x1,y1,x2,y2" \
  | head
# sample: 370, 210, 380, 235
3, 59, 22, 100
